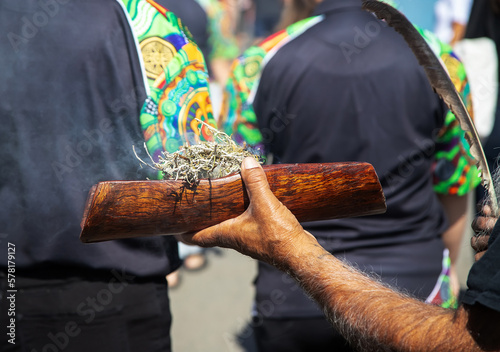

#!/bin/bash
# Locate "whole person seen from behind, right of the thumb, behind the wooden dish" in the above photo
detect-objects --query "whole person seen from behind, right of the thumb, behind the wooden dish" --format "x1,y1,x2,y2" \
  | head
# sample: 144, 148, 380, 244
220, 0, 479, 351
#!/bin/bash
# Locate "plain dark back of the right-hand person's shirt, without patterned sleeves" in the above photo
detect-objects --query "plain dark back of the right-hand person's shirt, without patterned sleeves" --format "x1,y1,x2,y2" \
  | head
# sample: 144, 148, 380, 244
254, 0, 447, 316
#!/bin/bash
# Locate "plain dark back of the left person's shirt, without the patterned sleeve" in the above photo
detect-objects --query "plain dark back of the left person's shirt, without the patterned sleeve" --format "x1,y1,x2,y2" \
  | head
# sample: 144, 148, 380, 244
0, 0, 178, 277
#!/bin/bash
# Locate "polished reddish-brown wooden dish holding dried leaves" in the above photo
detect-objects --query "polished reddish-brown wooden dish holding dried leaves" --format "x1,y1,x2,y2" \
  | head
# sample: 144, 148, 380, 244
80, 162, 386, 243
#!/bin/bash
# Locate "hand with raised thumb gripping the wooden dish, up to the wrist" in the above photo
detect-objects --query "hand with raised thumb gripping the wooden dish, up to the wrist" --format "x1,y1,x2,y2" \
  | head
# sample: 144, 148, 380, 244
179, 158, 317, 266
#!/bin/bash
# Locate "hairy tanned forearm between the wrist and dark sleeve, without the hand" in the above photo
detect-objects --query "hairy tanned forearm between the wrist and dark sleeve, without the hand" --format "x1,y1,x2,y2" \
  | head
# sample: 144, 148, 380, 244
285, 235, 480, 352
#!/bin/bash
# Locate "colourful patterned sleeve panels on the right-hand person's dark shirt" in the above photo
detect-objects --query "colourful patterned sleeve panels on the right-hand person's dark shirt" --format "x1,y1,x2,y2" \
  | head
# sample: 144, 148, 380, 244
219, 16, 481, 195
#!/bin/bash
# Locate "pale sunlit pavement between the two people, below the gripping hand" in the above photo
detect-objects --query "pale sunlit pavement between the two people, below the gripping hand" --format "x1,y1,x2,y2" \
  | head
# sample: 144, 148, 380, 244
170, 249, 257, 352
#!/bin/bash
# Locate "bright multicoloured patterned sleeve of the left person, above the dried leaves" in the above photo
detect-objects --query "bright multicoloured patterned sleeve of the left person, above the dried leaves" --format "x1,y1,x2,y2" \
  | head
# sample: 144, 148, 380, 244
122, 0, 215, 161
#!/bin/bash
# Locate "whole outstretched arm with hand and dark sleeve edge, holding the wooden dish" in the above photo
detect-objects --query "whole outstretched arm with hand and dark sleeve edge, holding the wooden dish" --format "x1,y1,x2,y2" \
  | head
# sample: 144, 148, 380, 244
182, 158, 500, 352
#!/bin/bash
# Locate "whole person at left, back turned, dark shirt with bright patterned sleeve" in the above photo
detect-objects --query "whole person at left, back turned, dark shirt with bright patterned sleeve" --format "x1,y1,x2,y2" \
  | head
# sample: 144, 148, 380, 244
0, 0, 214, 352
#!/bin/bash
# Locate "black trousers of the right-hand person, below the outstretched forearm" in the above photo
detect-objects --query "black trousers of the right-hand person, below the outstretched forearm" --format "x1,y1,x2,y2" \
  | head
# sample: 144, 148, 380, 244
253, 318, 354, 352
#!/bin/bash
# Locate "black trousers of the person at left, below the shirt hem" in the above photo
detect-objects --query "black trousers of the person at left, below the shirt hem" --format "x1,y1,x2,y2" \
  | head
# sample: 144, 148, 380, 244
0, 273, 171, 352
